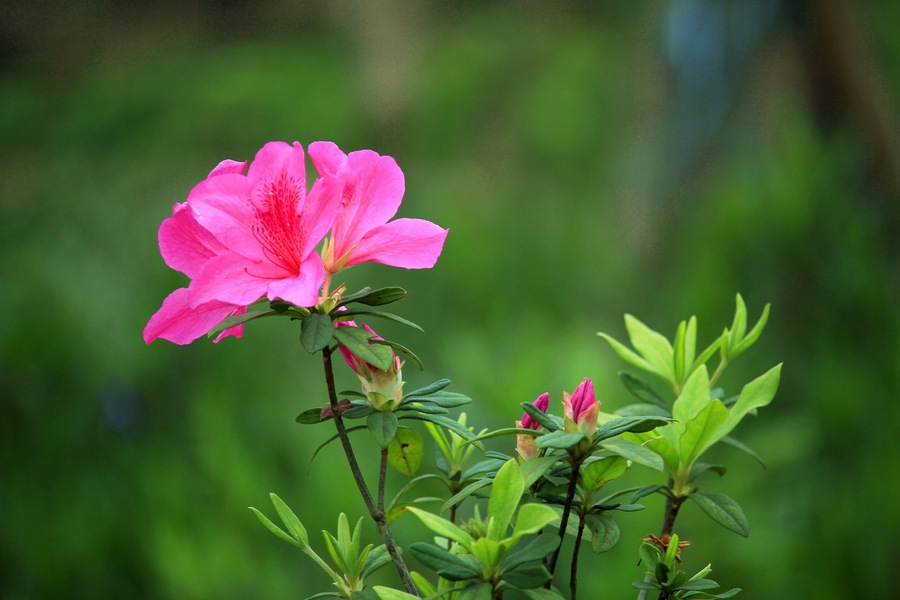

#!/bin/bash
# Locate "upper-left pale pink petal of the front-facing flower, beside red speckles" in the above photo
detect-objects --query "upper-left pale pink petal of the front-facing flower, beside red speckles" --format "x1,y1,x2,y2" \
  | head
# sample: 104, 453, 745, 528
187, 174, 262, 259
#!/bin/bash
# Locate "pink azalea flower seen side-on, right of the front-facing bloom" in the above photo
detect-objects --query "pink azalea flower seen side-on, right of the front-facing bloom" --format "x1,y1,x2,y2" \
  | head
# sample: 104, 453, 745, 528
309, 142, 447, 273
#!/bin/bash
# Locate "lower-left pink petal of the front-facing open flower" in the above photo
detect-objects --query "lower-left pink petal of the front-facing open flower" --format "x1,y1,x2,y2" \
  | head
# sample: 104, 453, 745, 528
190, 254, 278, 307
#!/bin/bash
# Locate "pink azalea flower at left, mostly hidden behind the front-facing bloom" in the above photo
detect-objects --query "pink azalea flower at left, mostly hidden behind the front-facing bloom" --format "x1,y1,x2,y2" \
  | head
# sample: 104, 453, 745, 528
144, 160, 247, 344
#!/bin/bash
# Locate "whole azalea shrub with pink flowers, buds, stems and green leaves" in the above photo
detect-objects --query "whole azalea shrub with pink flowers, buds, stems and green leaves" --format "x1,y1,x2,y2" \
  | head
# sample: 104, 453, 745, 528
144, 142, 780, 600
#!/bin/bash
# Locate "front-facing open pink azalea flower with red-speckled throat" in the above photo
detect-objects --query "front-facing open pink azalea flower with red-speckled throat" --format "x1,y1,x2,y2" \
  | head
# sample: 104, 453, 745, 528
187, 142, 343, 308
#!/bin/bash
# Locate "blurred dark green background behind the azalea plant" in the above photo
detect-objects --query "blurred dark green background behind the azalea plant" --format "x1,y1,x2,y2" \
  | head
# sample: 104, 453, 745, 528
0, 0, 900, 599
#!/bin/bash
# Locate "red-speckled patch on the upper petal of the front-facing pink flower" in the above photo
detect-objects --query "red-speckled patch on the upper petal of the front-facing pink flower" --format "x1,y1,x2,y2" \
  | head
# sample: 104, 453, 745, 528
253, 173, 304, 273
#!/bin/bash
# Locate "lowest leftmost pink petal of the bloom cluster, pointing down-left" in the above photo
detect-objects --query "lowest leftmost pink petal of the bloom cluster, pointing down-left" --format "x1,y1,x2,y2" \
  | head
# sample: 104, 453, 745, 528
144, 288, 243, 345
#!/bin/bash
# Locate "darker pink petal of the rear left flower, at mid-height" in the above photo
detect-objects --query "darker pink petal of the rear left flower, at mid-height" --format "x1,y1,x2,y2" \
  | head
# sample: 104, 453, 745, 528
158, 204, 227, 278
